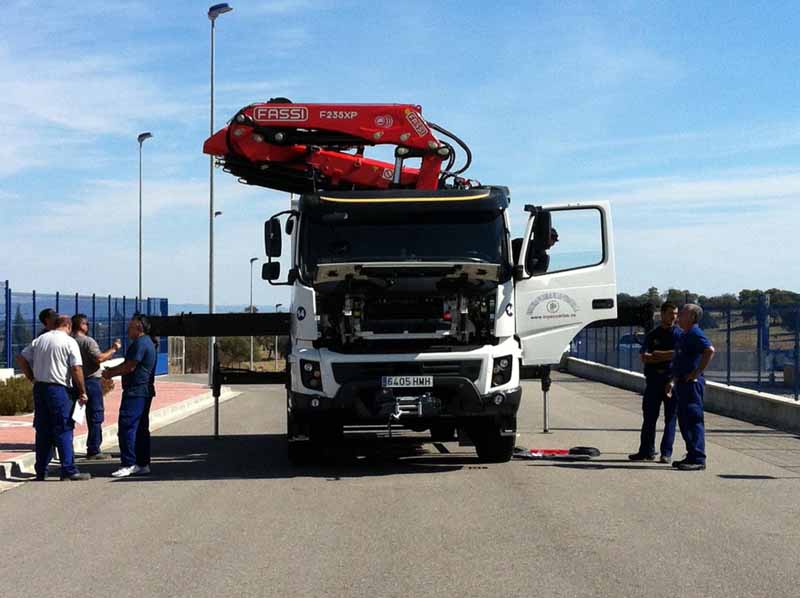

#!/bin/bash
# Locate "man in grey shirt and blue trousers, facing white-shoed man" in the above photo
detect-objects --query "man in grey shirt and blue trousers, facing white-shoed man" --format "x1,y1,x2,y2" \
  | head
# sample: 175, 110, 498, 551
72, 314, 122, 461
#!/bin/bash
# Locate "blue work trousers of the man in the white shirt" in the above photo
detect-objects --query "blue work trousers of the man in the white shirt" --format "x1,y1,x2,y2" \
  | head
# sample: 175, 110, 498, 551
33, 382, 78, 476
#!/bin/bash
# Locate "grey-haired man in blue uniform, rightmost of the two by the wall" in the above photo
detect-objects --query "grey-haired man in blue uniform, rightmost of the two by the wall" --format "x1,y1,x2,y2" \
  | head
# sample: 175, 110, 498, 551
667, 303, 714, 471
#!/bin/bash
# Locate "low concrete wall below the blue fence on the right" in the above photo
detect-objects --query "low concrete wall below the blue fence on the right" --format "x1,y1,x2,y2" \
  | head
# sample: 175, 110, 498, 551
567, 357, 800, 432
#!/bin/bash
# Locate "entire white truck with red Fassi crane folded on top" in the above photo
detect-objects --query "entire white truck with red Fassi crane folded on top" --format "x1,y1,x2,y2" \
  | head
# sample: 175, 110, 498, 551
204, 98, 617, 462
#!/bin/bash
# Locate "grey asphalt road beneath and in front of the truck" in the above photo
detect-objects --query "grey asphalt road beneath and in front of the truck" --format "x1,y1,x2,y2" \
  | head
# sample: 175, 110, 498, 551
0, 376, 800, 598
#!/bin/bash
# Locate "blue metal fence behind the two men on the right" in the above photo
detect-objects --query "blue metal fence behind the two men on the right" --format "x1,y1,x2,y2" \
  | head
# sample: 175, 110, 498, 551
570, 303, 800, 400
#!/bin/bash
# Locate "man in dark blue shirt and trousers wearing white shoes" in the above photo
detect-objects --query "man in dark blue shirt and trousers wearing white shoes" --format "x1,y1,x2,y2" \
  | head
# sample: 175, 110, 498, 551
103, 314, 156, 478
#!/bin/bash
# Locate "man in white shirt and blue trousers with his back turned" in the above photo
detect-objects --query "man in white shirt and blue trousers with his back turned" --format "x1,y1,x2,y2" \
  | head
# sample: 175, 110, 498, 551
17, 316, 92, 481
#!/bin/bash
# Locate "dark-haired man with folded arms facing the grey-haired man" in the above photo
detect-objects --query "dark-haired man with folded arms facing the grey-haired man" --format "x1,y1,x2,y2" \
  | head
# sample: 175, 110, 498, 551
628, 301, 681, 463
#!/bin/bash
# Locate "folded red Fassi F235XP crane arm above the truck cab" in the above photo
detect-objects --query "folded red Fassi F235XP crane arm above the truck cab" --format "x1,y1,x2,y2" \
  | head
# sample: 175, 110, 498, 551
203, 99, 460, 192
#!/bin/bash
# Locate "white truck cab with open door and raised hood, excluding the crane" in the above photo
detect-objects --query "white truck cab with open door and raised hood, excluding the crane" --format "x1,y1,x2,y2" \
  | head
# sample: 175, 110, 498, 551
263, 186, 616, 462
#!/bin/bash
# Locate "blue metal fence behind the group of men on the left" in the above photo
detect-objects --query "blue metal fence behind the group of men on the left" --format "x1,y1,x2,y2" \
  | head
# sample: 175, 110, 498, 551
0, 281, 169, 374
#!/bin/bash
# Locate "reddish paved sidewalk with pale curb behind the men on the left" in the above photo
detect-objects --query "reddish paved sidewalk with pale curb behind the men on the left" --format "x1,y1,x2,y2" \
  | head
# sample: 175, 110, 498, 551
0, 376, 238, 479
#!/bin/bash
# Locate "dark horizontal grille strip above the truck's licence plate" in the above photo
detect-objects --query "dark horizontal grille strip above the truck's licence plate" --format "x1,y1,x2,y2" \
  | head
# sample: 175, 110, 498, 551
333, 359, 481, 384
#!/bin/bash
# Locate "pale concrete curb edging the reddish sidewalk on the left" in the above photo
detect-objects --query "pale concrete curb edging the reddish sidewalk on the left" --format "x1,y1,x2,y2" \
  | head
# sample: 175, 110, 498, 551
0, 386, 241, 481
